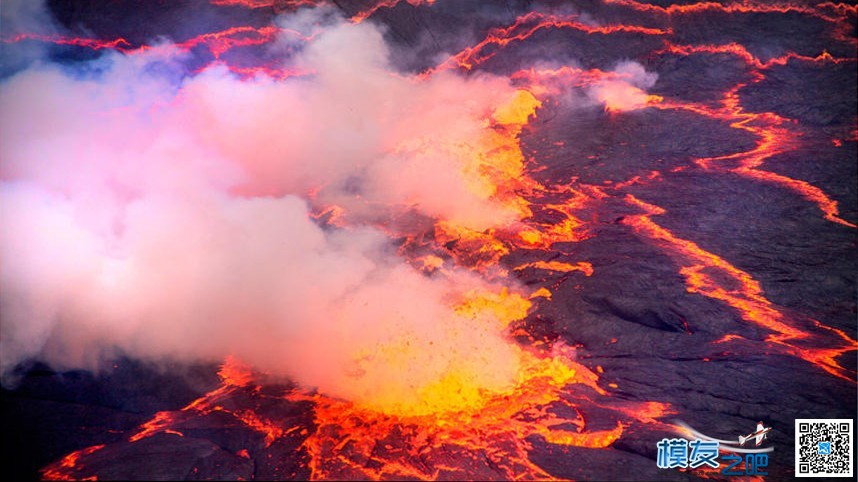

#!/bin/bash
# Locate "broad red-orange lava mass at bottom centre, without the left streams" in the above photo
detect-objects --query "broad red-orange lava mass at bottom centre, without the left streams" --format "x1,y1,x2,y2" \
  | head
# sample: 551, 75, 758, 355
294, 346, 623, 480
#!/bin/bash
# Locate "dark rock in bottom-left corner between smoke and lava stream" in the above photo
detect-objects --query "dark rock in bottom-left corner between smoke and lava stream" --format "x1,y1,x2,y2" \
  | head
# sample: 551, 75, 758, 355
0, 359, 218, 480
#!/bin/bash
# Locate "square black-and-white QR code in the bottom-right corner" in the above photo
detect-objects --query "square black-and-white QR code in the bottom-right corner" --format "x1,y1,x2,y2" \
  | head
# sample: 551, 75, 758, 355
795, 418, 853, 477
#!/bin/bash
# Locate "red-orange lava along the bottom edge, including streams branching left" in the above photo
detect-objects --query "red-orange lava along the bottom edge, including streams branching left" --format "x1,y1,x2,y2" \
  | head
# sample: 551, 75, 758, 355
43, 346, 669, 480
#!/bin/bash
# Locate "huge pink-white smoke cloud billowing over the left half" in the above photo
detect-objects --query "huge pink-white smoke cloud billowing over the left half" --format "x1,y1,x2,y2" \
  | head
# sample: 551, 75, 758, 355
0, 5, 518, 413
